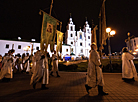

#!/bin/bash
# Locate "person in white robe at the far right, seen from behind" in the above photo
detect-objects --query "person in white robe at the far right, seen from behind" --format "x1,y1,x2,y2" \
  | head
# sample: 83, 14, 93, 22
122, 47, 137, 81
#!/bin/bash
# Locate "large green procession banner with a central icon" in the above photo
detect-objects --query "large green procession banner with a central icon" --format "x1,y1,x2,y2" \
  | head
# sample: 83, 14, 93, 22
41, 13, 57, 52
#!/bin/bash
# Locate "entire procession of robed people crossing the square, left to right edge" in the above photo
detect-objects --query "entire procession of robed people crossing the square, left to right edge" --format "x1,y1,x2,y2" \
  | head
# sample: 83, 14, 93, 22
0, 43, 137, 95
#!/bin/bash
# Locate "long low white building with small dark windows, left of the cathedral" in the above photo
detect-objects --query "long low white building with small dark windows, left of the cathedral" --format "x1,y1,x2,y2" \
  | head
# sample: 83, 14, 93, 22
0, 40, 70, 58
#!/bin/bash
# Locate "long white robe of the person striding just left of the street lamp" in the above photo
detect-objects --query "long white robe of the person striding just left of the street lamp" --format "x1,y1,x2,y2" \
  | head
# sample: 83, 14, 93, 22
86, 50, 104, 87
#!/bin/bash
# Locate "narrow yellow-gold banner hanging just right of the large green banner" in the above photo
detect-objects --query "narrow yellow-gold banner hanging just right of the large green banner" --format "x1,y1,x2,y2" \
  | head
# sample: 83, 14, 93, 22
56, 30, 64, 52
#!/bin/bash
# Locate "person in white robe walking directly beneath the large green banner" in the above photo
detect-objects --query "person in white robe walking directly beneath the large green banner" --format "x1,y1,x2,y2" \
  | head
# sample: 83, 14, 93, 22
30, 51, 49, 89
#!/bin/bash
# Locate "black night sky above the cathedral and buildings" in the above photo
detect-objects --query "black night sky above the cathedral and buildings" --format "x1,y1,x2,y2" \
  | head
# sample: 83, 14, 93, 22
0, 0, 138, 53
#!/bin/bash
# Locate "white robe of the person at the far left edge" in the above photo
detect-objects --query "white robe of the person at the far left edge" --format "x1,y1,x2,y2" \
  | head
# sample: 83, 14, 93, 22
0, 55, 13, 80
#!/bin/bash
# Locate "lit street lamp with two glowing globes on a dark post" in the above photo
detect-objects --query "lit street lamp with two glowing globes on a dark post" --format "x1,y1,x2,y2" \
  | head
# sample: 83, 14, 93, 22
106, 28, 116, 72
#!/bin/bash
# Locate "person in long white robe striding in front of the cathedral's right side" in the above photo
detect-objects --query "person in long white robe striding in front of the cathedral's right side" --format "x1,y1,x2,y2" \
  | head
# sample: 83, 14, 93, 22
85, 43, 108, 95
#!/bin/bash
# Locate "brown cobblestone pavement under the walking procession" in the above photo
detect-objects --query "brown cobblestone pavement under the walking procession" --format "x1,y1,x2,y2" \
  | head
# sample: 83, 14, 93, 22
0, 72, 138, 102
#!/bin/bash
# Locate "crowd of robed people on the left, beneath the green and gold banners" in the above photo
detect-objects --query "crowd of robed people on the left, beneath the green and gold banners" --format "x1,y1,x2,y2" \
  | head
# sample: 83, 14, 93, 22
0, 49, 60, 89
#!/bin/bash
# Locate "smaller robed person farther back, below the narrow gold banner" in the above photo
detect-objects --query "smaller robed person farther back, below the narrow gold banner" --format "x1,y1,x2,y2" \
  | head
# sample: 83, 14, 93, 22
50, 51, 60, 77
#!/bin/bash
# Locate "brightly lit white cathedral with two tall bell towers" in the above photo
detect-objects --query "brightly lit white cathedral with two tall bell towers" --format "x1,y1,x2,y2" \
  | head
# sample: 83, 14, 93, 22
65, 17, 92, 57
